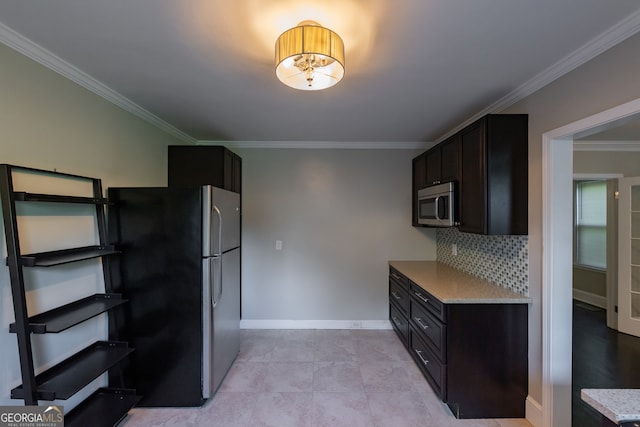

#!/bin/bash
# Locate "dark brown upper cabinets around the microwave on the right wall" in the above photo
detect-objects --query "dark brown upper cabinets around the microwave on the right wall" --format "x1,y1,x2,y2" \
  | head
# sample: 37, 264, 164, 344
412, 114, 528, 235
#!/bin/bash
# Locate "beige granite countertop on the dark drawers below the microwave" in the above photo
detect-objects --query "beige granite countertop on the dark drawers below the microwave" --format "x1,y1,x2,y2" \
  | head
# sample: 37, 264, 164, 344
389, 261, 531, 304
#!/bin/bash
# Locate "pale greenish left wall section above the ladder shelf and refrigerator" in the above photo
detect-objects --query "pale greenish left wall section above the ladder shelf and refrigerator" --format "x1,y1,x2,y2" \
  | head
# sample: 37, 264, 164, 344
0, 44, 182, 188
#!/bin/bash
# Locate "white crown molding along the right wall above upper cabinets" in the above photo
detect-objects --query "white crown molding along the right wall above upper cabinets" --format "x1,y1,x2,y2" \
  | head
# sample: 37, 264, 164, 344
436, 10, 640, 142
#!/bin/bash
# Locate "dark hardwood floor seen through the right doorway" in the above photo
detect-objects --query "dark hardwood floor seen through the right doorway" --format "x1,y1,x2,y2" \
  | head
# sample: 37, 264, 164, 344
572, 300, 640, 427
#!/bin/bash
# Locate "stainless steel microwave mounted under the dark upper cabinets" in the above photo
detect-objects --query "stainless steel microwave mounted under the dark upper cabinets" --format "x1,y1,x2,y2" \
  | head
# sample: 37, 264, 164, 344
417, 182, 455, 227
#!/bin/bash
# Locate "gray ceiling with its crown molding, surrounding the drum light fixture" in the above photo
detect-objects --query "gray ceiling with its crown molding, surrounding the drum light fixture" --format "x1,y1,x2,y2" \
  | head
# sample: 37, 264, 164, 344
0, 0, 640, 146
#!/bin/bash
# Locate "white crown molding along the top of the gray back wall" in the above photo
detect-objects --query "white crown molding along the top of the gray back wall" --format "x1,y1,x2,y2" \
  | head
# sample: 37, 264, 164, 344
204, 140, 435, 150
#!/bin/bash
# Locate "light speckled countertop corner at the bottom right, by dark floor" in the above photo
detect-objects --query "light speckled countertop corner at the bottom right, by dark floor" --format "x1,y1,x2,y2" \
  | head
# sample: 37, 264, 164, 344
580, 388, 640, 424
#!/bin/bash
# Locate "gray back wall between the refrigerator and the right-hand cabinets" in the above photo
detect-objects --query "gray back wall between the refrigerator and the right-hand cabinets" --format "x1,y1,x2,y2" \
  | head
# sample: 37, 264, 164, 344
234, 148, 436, 328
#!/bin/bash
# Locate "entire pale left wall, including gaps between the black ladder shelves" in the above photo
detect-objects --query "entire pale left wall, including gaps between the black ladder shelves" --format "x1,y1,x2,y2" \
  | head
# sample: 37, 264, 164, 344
0, 44, 186, 411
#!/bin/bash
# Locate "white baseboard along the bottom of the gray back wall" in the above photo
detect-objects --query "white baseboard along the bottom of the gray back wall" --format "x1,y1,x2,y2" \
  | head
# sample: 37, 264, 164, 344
240, 319, 391, 329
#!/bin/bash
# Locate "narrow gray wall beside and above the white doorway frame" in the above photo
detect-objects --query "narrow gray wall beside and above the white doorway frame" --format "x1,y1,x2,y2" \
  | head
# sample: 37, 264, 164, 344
502, 30, 640, 403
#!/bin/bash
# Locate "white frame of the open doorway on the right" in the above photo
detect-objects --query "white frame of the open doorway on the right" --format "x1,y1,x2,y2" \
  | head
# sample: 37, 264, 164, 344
541, 98, 640, 427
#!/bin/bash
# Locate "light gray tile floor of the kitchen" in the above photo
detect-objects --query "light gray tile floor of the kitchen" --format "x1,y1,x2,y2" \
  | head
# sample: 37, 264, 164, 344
122, 330, 531, 427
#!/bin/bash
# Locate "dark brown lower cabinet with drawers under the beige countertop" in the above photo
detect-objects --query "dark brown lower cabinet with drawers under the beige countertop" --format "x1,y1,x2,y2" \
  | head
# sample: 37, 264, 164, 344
389, 268, 528, 418
